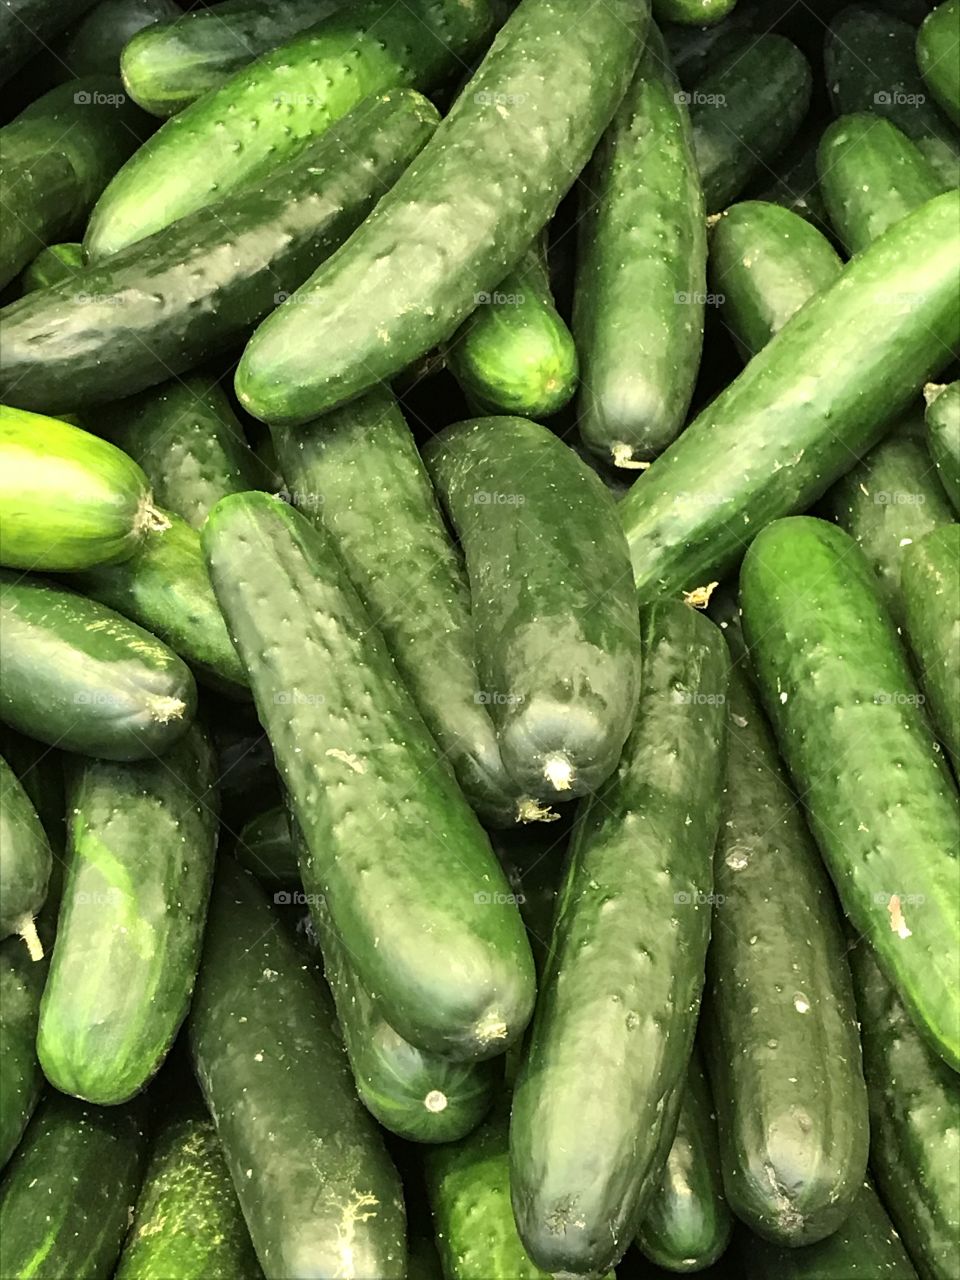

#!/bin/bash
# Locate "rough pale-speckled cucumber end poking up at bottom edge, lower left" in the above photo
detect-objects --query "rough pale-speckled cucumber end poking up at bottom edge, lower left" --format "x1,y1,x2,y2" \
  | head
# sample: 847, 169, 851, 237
114, 1100, 261, 1280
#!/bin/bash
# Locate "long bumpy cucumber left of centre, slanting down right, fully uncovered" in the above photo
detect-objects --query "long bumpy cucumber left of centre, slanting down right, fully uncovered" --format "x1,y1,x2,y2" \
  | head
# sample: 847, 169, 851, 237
202, 493, 534, 1059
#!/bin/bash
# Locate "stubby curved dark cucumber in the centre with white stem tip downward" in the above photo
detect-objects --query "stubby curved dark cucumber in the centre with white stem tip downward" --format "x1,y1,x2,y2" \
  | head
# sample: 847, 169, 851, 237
425, 417, 640, 800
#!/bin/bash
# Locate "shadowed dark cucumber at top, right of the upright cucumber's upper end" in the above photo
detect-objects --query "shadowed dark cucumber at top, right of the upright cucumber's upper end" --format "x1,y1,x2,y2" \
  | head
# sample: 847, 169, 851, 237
690, 32, 813, 214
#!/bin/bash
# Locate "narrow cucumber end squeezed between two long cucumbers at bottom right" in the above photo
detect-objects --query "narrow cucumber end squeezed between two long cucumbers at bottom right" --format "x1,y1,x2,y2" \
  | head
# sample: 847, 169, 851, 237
637, 1050, 733, 1272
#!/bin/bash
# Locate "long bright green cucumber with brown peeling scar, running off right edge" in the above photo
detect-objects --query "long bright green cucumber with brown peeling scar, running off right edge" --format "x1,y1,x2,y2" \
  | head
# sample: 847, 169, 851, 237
740, 516, 960, 1070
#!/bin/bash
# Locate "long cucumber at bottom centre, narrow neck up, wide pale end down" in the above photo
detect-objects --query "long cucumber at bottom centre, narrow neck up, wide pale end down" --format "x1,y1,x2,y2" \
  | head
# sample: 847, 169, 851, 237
511, 602, 730, 1274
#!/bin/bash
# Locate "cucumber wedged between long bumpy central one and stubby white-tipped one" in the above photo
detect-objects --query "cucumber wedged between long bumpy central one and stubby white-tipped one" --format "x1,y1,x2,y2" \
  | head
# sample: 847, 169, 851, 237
271, 389, 521, 827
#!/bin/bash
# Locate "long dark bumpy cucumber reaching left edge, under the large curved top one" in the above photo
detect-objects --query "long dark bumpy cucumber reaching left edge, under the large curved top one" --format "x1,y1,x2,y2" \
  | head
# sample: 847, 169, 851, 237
0, 90, 436, 412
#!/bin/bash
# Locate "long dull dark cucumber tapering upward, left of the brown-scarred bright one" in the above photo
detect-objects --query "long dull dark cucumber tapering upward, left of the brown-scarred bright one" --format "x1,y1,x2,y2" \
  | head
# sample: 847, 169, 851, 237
703, 665, 868, 1248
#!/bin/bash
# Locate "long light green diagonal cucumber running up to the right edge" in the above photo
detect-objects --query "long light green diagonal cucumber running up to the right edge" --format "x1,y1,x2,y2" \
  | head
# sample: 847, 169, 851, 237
620, 192, 960, 602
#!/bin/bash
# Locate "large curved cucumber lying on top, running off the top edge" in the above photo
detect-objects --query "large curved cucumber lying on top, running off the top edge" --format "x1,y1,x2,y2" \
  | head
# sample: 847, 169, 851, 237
237, 0, 648, 425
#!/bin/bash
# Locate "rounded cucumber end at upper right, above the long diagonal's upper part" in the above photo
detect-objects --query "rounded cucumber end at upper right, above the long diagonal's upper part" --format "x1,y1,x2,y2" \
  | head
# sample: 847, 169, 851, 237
817, 111, 945, 253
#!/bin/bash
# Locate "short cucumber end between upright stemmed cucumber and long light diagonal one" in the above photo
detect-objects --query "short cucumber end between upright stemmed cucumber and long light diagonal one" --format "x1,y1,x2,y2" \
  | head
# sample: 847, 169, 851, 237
710, 200, 844, 361
